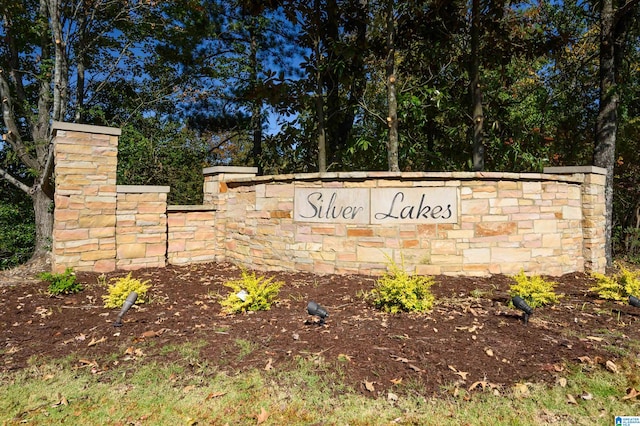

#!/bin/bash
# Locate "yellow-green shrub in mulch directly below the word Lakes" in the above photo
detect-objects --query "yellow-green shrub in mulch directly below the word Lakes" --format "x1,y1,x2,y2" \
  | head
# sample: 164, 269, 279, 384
366, 261, 435, 314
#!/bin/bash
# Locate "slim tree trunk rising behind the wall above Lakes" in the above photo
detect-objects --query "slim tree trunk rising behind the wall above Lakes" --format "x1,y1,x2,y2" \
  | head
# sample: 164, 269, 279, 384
386, 0, 400, 172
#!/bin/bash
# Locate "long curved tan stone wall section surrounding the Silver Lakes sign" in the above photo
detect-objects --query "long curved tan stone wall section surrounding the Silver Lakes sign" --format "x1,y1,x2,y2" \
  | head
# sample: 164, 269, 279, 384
208, 169, 604, 275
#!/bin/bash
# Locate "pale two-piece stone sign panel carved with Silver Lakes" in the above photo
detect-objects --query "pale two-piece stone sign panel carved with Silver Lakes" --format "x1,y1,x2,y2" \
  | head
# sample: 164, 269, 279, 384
293, 187, 458, 224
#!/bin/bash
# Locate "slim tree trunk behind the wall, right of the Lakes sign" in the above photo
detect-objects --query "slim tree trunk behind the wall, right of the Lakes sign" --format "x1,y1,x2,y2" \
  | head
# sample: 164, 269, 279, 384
469, 0, 484, 171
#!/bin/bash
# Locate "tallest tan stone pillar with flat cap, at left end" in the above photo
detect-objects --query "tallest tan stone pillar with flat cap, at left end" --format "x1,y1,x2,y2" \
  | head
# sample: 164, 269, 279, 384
52, 122, 121, 272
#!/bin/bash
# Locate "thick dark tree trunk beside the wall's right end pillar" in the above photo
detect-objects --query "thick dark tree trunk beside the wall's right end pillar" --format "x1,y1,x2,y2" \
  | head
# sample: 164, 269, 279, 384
593, 0, 618, 266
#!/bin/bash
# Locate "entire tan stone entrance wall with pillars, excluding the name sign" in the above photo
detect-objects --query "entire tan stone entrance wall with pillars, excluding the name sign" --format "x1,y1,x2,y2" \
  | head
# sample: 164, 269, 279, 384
53, 123, 606, 275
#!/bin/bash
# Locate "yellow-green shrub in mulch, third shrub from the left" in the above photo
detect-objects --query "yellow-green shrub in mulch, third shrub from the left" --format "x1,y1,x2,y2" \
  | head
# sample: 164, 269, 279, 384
220, 270, 284, 314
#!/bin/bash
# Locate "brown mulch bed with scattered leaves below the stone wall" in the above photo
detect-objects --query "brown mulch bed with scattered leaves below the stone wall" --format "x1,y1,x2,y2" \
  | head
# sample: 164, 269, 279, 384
0, 263, 640, 396
